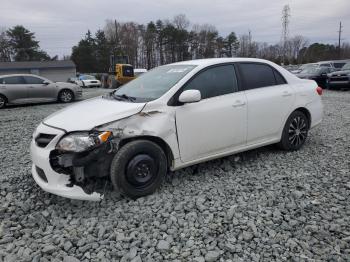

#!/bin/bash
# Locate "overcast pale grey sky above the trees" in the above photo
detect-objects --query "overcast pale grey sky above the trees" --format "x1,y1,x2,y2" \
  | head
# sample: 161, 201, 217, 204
0, 0, 350, 57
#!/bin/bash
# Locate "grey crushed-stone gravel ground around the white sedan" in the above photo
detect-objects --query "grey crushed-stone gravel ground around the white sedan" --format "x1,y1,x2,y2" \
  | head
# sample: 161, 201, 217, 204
0, 89, 350, 262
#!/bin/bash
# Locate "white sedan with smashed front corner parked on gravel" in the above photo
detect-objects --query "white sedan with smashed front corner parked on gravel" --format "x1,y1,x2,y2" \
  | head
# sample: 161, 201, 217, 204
31, 58, 322, 200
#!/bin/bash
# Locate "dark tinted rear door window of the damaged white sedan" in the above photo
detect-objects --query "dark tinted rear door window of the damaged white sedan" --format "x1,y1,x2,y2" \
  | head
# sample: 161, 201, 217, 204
239, 63, 278, 90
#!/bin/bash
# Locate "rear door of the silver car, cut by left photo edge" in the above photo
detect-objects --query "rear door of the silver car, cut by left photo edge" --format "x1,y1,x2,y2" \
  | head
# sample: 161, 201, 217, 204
0, 76, 27, 103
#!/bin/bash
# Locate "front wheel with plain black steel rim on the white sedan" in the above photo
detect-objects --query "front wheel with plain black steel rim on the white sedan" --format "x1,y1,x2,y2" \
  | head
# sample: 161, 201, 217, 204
111, 140, 167, 199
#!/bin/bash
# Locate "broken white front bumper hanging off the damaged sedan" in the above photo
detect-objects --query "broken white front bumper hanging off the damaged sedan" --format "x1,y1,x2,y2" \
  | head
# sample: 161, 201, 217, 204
30, 124, 103, 201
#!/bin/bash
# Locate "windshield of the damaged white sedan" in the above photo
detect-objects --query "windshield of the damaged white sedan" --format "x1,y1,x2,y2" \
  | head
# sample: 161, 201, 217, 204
112, 65, 195, 102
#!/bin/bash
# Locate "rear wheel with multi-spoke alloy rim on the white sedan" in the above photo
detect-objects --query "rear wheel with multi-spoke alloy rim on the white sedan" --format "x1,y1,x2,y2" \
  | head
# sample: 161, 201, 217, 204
277, 111, 310, 151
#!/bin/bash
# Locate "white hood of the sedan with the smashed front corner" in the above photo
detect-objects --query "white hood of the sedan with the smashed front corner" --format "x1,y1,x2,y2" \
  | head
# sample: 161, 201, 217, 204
43, 97, 145, 132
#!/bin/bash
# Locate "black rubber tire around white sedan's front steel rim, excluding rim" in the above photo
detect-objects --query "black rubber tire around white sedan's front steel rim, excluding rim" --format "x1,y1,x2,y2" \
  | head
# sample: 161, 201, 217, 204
111, 140, 167, 199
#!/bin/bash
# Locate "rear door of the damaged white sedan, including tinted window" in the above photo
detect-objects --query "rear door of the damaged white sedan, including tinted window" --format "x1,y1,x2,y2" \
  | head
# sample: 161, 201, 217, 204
239, 62, 295, 145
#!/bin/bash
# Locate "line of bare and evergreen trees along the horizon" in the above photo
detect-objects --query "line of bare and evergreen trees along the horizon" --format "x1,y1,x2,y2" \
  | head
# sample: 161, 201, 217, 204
0, 15, 350, 73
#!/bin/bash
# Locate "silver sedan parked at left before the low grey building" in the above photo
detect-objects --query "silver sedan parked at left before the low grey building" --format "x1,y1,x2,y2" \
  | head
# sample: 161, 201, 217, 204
0, 74, 82, 108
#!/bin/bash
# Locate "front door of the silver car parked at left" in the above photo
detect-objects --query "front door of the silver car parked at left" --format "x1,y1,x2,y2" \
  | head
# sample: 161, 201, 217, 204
23, 76, 56, 101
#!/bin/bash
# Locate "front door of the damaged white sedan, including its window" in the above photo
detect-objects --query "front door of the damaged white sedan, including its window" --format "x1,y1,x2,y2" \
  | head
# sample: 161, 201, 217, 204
176, 64, 247, 162
